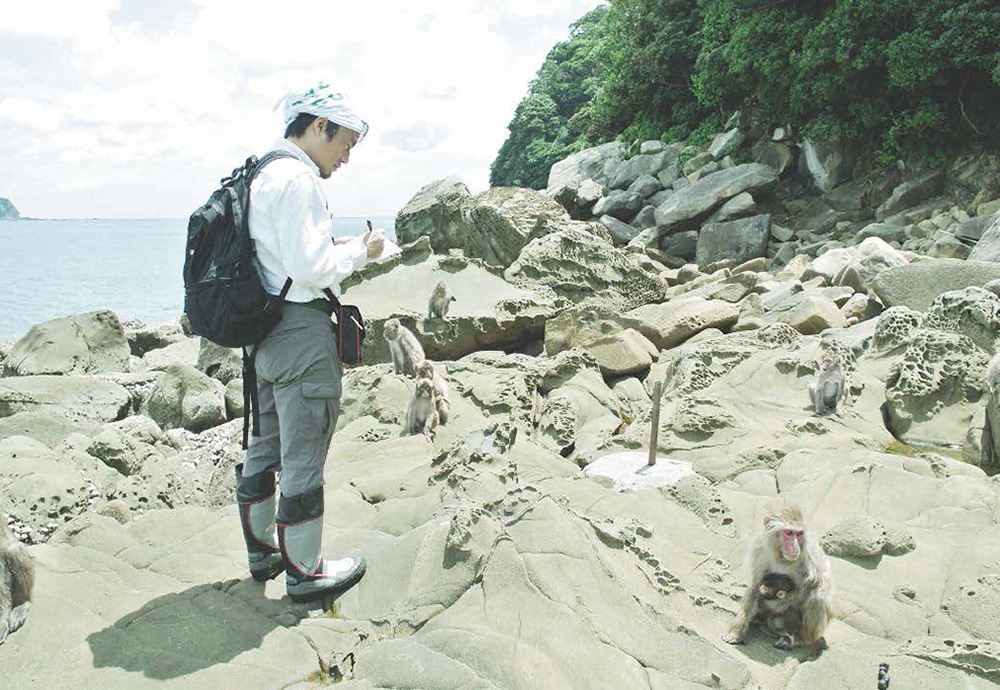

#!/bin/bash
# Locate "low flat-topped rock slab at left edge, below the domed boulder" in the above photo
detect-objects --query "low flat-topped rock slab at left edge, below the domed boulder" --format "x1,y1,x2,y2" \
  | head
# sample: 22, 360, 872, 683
0, 376, 131, 422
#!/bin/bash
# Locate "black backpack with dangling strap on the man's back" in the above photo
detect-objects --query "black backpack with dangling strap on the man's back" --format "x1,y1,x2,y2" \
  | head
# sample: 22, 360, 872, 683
184, 151, 294, 448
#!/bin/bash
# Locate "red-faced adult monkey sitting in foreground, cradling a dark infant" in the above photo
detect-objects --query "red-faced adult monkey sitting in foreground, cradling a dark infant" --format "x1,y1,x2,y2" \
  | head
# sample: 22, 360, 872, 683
722, 506, 833, 646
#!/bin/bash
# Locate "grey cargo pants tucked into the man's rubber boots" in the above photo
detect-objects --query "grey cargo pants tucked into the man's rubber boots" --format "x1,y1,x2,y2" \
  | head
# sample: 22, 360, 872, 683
243, 303, 343, 497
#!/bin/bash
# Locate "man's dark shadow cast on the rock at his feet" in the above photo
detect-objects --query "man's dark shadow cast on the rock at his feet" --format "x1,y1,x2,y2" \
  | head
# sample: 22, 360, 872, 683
87, 579, 318, 680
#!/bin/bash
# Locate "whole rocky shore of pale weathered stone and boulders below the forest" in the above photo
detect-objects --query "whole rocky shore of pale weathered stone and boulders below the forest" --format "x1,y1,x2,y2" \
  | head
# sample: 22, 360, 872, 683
0, 122, 1000, 690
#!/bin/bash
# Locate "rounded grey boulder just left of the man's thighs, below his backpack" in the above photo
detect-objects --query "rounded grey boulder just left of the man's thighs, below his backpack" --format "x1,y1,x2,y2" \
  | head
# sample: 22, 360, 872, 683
144, 364, 226, 433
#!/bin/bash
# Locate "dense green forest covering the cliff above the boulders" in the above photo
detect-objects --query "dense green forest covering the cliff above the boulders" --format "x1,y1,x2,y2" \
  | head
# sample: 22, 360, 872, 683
490, 0, 1000, 189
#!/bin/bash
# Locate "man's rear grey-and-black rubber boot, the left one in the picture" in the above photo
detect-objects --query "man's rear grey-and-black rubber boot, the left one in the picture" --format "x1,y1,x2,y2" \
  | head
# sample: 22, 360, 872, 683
236, 463, 284, 582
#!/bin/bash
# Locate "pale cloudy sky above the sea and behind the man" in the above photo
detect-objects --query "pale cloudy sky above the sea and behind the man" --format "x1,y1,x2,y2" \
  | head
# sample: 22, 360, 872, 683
0, 0, 603, 218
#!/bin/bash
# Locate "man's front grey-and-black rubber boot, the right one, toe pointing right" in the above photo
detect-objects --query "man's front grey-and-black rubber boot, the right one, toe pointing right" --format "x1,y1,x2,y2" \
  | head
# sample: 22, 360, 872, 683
278, 487, 366, 602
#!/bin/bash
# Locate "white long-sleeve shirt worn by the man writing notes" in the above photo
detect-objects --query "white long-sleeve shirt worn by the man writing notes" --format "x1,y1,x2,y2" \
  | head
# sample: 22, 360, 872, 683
250, 139, 368, 302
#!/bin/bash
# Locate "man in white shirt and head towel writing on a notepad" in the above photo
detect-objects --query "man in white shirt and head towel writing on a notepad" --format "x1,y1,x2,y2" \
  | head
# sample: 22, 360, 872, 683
236, 83, 383, 601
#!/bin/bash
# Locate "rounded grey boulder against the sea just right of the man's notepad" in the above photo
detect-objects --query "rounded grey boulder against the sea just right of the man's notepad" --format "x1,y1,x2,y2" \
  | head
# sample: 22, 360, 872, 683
396, 177, 470, 254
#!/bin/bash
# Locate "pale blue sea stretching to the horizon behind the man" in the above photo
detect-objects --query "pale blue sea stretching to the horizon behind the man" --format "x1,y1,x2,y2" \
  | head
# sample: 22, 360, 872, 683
0, 216, 396, 340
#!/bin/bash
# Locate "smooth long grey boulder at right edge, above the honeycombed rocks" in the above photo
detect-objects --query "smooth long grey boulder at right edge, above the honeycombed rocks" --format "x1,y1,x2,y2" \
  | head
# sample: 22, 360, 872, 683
871, 259, 1000, 311
